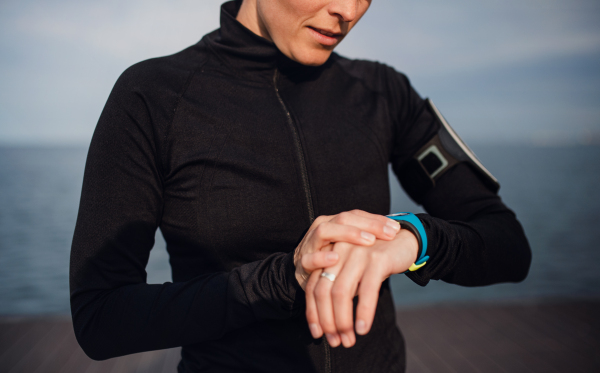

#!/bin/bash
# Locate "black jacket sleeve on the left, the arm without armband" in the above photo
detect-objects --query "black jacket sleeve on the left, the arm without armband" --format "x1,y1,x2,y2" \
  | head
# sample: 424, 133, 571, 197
70, 67, 303, 360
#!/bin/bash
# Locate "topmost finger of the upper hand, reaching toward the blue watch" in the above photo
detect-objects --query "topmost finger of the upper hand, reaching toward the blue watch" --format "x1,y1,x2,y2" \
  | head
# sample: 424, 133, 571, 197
329, 210, 400, 240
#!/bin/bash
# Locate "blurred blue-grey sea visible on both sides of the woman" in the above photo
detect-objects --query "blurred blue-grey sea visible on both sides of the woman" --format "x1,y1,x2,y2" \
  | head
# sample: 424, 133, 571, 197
0, 145, 600, 315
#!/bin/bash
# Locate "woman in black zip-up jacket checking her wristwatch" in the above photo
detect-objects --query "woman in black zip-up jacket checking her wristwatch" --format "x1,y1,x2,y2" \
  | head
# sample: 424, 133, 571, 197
71, 0, 530, 372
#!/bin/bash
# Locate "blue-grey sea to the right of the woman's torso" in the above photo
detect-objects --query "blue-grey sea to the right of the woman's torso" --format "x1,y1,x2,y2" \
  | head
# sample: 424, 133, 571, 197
391, 146, 600, 306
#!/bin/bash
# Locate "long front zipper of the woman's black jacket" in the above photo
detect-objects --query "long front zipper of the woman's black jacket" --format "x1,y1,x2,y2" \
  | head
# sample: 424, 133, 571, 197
273, 69, 331, 373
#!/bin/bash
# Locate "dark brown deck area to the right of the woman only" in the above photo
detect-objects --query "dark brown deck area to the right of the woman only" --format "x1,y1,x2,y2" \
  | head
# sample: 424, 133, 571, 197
397, 301, 600, 373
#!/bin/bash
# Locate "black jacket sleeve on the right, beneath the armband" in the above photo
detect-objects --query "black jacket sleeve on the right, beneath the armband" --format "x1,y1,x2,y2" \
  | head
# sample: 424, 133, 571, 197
388, 69, 531, 286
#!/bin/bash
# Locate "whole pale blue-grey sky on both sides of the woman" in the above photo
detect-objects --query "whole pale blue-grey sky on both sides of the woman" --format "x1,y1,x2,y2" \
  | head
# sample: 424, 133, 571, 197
0, 0, 600, 146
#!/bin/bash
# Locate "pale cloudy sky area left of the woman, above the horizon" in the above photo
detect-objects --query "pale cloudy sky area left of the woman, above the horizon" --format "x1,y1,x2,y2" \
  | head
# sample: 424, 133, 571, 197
0, 0, 221, 143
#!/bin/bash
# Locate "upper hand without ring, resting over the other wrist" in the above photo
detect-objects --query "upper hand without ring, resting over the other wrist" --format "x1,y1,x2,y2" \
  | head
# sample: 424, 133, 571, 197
294, 210, 400, 289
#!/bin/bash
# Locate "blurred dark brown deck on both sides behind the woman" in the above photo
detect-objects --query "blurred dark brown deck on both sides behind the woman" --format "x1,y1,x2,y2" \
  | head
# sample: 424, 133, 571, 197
0, 301, 600, 373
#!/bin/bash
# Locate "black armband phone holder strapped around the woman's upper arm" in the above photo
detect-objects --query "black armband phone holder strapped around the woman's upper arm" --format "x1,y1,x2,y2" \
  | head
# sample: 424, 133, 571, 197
398, 99, 500, 203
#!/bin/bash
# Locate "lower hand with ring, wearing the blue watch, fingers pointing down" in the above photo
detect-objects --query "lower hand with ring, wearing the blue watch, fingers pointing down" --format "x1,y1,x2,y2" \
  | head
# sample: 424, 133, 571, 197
306, 229, 419, 347
